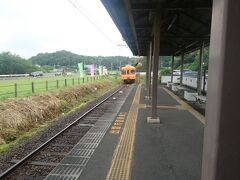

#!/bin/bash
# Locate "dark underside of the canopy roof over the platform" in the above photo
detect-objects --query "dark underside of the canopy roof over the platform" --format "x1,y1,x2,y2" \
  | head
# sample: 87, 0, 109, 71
101, 0, 212, 56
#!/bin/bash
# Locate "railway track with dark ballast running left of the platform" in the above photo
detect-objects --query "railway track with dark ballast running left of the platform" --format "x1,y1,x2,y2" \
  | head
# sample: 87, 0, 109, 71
0, 86, 127, 179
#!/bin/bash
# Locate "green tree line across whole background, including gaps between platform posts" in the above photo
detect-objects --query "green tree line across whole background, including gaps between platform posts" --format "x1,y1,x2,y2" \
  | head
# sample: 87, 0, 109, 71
0, 48, 209, 74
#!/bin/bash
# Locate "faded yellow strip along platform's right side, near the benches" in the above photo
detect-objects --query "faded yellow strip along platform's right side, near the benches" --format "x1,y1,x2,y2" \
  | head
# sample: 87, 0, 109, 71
163, 88, 206, 124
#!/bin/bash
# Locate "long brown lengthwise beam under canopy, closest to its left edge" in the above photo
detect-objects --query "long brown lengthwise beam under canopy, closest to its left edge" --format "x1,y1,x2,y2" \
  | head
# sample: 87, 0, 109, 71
124, 0, 140, 55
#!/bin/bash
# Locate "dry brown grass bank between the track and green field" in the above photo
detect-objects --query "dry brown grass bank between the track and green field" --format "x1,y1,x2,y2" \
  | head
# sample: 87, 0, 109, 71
0, 78, 120, 153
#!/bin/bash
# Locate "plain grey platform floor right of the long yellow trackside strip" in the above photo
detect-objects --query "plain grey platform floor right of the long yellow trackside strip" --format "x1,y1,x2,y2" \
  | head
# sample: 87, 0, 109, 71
130, 87, 204, 180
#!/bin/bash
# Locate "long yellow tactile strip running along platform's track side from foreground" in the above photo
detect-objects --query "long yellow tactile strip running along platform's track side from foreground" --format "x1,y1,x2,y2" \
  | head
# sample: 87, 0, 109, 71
106, 85, 141, 180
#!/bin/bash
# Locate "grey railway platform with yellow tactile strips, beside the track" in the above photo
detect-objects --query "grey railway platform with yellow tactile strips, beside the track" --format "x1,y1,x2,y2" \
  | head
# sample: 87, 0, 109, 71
46, 85, 205, 180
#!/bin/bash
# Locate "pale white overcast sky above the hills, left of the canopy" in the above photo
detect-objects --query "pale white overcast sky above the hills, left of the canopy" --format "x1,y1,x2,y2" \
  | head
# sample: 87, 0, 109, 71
0, 0, 132, 58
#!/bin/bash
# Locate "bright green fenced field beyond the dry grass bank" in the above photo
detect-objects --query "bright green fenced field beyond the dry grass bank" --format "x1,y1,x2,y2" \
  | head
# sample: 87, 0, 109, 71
0, 76, 101, 100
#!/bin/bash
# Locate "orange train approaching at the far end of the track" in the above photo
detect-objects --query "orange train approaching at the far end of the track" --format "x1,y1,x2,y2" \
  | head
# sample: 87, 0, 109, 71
121, 65, 136, 84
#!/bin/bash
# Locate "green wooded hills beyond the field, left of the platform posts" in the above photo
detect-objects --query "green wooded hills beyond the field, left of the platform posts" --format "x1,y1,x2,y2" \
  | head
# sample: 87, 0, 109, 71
0, 50, 134, 74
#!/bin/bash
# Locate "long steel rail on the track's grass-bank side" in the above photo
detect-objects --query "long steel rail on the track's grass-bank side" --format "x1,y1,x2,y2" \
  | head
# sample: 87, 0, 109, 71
0, 85, 123, 179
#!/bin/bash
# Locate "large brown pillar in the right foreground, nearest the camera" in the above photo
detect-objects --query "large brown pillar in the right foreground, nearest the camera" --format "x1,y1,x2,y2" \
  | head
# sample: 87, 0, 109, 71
202, 0, 240, 180
